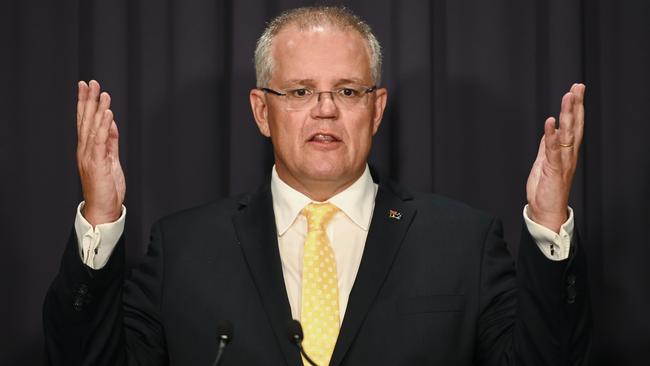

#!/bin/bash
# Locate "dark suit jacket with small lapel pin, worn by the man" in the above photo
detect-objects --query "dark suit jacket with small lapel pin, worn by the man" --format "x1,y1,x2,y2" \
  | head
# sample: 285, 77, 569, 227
44, 173, 589, 366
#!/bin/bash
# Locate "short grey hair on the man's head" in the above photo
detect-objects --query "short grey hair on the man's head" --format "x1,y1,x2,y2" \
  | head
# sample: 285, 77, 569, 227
255, 6, 382, 88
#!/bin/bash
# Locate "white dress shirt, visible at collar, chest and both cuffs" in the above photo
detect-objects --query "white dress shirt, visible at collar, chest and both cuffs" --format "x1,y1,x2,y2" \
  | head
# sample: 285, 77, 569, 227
75, 166, 573, 320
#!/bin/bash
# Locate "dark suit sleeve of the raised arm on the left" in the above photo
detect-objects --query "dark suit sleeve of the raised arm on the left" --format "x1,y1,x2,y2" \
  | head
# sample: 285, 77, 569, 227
43, 225, 168, 366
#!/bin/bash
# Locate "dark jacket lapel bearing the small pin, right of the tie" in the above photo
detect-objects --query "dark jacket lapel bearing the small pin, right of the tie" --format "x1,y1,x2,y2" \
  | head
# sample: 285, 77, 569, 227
330, 184, 416, 366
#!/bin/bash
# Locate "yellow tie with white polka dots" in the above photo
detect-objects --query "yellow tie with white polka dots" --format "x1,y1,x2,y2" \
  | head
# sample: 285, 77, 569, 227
300, 203, 340, 366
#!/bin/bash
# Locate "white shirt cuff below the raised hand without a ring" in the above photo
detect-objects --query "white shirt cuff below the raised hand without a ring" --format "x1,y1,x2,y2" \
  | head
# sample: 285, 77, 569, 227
74, 201, 126, 269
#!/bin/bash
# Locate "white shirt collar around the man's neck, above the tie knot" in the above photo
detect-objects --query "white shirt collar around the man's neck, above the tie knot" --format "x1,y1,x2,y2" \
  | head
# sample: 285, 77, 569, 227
271, 164, 377, 236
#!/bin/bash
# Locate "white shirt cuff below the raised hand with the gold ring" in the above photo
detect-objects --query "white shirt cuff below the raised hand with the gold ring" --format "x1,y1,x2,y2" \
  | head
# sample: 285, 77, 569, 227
524, 205, 574, 261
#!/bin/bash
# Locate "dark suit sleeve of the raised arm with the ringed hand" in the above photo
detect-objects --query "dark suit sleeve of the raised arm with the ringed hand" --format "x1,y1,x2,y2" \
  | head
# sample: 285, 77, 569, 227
476, 220, 591, 366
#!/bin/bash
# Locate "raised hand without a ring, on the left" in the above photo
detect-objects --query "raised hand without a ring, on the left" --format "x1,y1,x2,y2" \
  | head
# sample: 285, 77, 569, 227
77, 80, 126, 227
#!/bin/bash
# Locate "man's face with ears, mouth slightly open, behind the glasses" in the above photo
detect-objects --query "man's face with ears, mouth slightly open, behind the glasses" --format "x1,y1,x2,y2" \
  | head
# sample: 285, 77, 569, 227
250, 26, 387, 200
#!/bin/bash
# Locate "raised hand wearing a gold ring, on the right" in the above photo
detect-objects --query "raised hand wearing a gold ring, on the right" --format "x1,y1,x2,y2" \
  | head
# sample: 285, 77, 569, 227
526, 84, 585, 232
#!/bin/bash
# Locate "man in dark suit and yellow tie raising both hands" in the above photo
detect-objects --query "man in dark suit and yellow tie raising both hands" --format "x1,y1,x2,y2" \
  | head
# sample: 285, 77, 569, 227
44, 7, 589, 365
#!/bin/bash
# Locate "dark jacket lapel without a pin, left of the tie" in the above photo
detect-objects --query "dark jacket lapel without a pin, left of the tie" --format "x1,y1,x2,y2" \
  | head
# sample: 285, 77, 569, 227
233, 184, 300, 365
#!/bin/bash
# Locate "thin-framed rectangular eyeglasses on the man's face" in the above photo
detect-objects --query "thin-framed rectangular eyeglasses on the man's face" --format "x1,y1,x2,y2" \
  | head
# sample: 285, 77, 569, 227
260, 86, 377, 111
